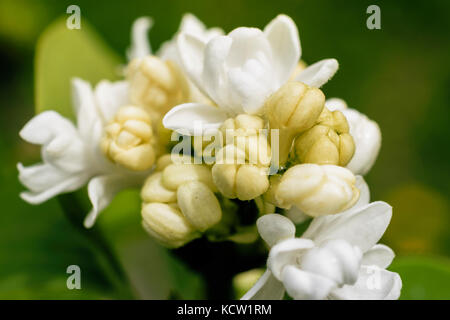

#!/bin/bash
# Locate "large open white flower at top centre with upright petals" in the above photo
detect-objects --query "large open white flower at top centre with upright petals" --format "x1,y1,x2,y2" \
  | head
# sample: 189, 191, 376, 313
164, 15, 338, 134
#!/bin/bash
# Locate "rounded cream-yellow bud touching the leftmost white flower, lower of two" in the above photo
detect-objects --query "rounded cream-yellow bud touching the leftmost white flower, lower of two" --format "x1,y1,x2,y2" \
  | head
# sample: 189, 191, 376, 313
100, 106, 155, 171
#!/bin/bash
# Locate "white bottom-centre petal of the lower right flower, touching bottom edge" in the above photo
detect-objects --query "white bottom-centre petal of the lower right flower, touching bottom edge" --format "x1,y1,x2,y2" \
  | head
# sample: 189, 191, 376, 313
283, 266, 336, 300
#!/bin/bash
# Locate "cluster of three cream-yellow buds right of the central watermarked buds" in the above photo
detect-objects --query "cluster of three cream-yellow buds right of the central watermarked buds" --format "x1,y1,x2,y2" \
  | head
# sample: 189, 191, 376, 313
264, 82, 359, 217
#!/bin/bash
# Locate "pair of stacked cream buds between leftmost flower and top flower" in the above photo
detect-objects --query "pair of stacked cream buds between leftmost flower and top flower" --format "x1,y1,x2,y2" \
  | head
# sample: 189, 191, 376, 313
100, 55, 189, 171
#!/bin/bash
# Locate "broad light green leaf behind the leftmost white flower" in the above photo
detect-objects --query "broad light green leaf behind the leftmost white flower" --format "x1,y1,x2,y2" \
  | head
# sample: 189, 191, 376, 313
35, 18, 121, 118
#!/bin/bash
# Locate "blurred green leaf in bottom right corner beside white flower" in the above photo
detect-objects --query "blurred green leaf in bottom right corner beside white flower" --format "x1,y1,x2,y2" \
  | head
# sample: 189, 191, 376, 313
389, 256, 450, 300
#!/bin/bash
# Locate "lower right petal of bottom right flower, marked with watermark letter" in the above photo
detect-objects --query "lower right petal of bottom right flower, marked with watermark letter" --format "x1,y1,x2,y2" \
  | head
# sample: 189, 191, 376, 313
330, 266, 402, 300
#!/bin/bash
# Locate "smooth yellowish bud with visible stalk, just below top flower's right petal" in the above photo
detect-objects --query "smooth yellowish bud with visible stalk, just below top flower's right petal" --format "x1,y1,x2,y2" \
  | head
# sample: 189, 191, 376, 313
265, 82, 325, 165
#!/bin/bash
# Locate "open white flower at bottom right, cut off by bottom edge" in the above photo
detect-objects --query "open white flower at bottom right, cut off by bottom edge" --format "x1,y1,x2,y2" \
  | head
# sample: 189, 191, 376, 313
242, 179, 402, 300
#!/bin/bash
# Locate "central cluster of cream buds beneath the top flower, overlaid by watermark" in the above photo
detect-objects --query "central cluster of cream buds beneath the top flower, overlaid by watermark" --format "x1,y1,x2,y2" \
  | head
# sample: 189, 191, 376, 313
212, 114, 271, 200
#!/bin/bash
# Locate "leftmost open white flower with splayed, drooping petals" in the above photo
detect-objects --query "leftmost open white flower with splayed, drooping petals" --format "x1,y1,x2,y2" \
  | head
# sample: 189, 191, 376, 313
18, 79, 148, 227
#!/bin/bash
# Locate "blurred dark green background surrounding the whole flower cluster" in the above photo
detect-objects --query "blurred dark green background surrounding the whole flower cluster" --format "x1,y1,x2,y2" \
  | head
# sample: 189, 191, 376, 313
0, 0, 450, 299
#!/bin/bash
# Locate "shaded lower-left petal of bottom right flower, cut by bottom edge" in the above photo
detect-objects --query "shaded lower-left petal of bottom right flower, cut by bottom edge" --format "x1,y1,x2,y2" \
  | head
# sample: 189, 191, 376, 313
241, 270, 284, 300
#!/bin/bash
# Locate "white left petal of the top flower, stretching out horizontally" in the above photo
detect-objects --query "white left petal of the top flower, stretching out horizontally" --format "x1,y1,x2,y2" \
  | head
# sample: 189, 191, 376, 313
163, 103, 227, 135
